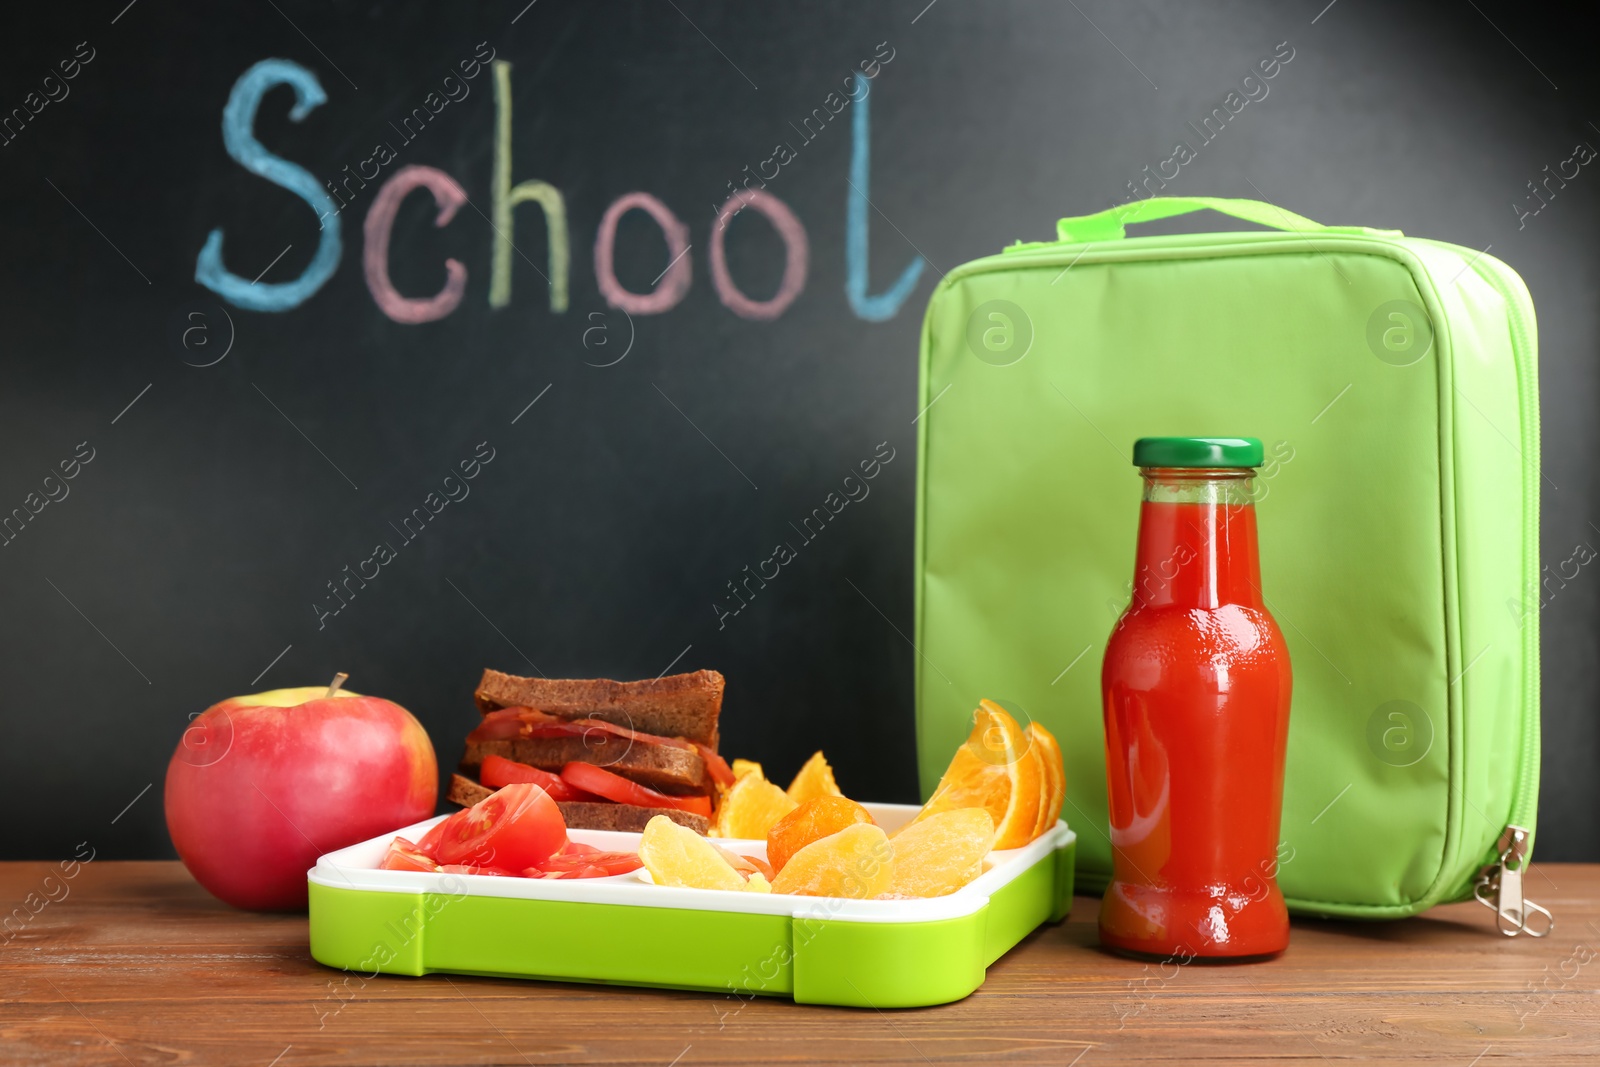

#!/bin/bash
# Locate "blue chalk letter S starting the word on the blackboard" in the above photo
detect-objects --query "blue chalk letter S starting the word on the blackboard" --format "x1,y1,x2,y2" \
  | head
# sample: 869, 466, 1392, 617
195, 59, 339, 312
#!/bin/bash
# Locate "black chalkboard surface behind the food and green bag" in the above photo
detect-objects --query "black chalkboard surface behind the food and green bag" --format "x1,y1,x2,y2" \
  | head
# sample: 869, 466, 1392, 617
0, 0, 1600, 859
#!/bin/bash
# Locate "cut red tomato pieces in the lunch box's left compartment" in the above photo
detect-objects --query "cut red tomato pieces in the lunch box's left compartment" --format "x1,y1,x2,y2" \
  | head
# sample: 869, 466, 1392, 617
378, 782, 640, 878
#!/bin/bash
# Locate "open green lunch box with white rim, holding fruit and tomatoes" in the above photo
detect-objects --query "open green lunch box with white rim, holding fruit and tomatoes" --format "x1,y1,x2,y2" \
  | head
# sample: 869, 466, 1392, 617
307, 805, 1077, 1008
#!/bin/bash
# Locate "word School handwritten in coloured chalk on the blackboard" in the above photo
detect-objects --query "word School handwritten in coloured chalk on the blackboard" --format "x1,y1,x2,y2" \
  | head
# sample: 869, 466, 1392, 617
195, 42, 923, 325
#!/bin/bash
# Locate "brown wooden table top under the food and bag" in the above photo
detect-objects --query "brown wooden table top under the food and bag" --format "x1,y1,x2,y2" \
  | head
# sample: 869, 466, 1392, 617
0, 861, 1600, 1067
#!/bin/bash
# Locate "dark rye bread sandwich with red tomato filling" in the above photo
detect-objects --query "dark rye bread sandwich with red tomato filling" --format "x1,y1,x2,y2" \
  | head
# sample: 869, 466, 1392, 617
448, 670, 734, 833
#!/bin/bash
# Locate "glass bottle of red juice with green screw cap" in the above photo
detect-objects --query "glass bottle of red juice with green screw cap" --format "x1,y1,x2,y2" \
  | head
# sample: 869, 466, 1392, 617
1099, 437, 1291, 961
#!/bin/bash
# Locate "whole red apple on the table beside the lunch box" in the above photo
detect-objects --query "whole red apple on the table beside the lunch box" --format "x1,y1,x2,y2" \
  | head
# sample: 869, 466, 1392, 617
166, 685, 438, 910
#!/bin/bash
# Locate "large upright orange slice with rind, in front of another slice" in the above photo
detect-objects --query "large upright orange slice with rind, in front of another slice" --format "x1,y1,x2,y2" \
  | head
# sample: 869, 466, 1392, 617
912, 701, 1043, 848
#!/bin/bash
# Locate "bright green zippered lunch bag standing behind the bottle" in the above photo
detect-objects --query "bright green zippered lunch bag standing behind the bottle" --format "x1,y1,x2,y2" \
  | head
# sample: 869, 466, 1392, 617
915, 197, 1549, 934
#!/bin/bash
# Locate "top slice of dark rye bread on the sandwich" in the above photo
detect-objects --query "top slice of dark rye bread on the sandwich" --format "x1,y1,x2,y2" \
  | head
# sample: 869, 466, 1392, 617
472, 670, 726, 749
